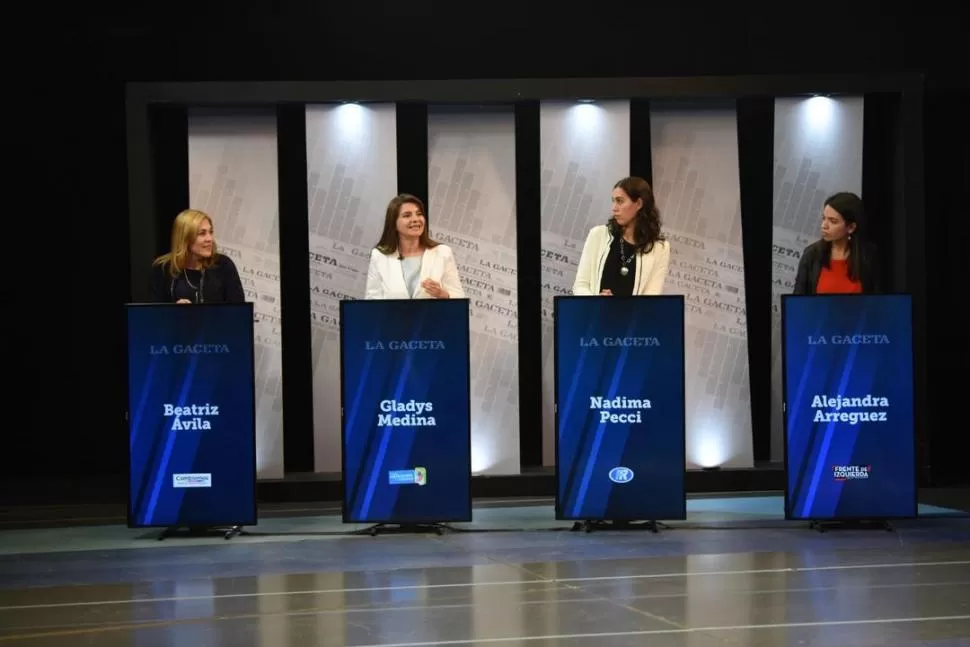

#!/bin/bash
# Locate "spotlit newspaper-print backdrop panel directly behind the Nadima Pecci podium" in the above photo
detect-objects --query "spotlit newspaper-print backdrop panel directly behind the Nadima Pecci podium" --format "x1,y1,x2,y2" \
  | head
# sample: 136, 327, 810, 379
539, 101, 630, 465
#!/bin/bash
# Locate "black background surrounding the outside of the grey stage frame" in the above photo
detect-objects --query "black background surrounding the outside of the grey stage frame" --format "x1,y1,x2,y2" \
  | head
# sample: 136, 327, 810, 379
0, 0, 970, 496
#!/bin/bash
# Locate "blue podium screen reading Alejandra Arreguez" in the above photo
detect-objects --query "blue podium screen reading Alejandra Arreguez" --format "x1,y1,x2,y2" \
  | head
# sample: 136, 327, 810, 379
782, 295, 917, 521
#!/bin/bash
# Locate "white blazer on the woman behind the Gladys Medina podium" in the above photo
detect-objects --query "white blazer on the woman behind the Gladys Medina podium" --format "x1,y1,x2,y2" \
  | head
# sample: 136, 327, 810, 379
364, 244, 465, 299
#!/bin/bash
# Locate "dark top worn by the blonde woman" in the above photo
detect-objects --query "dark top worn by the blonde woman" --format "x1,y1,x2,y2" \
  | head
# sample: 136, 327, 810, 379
152, 254, 246, 303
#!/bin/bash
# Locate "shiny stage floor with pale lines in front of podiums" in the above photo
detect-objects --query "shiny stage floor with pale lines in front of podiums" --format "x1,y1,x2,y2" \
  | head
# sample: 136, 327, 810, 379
0, 495, 970, 647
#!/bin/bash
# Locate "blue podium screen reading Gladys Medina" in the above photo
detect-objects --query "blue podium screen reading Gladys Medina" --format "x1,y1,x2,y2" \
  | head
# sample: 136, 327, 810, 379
340, 299, 471, 524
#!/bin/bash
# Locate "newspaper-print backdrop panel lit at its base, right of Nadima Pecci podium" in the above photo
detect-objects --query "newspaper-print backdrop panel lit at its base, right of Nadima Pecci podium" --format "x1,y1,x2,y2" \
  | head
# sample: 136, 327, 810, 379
650, 102, 754, 467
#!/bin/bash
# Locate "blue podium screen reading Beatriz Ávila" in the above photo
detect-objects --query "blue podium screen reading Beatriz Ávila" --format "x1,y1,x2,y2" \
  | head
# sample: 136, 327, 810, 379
126, 303, 256, 527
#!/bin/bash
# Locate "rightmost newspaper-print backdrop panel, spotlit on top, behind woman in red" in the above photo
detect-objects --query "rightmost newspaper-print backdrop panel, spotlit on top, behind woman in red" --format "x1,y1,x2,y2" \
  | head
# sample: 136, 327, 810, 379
771, 97, 863, 461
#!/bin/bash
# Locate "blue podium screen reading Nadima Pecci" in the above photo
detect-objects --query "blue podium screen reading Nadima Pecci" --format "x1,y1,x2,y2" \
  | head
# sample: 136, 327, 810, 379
554, 295, 687, 521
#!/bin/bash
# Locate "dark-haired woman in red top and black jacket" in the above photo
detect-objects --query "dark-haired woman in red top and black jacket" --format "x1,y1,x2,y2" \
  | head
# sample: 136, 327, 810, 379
794, 192, 879, 294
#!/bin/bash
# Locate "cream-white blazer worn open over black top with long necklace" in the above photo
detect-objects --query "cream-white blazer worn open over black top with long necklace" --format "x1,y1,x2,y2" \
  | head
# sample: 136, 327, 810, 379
573, 225, 670, 296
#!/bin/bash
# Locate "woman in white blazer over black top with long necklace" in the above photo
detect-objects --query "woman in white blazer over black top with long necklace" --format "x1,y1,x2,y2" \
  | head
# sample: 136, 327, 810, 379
573, 177, 670, 296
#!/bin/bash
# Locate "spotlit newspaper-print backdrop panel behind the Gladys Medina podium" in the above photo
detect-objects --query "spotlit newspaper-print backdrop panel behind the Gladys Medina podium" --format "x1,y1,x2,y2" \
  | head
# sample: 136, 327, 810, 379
306, 103, 397, 473
